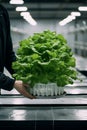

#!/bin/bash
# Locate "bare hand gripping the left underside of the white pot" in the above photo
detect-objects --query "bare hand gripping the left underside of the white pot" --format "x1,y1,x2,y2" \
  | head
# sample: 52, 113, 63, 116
14, 80, 35, 99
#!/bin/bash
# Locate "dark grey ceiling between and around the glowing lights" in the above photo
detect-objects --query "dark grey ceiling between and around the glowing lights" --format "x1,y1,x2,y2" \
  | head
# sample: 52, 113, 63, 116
0, 0, 87, 20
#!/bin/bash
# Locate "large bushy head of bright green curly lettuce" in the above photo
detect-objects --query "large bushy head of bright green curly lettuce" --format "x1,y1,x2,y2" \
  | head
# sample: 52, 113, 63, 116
12, 30, 77, 87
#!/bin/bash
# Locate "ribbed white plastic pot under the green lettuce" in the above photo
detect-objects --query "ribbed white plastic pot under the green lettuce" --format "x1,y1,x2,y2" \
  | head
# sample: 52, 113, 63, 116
28, 83, 64, 96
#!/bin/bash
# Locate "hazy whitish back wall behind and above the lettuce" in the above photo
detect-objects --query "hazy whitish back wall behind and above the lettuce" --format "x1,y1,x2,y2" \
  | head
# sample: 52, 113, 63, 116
11, 19, 87, 55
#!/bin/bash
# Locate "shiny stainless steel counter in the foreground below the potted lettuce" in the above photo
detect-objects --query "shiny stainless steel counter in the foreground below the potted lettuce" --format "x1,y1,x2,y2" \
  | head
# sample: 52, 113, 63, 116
0, 94, 87, 130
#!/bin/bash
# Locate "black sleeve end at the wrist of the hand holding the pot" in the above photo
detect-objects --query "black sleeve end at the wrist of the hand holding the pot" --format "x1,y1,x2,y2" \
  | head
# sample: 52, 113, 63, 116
0, 72, 15, 91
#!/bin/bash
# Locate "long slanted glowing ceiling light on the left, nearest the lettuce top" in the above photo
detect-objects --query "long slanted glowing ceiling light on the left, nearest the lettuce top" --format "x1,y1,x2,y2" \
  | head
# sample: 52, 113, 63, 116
20, 12, 37, 26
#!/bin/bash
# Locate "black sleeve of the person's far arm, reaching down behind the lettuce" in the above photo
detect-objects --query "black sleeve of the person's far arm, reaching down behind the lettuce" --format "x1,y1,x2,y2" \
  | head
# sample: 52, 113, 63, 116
4, 4, 16, 74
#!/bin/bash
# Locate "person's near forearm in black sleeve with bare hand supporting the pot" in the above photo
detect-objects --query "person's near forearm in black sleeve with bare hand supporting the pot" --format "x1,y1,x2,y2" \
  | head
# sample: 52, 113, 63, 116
0, 72, 35, 99
